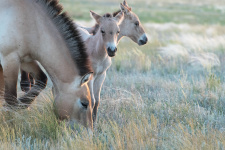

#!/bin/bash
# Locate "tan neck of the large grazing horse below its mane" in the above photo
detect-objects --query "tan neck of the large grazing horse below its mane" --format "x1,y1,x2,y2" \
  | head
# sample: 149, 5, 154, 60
31, 4, 78, 85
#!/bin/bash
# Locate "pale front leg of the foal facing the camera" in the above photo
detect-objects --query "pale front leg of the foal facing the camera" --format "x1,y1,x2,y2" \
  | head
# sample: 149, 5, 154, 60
93, 72, 106, 123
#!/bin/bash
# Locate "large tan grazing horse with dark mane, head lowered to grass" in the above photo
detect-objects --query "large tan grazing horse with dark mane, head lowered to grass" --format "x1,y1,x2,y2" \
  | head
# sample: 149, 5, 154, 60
0, 0, 93, 129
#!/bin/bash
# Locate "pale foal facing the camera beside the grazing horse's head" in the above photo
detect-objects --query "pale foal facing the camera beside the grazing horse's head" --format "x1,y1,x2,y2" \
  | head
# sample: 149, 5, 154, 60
77, 11, 124, 122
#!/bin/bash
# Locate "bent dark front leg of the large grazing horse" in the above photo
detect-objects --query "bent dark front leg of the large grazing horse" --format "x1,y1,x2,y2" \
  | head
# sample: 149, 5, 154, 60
19, 61, 48, 107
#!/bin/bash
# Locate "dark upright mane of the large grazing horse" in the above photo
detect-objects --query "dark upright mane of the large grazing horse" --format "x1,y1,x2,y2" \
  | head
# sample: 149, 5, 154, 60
35, 0, 92, 76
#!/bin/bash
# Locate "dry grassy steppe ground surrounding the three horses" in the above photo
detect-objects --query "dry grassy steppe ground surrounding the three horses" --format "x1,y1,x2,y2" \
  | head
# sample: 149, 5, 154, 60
0, 0, 225, 150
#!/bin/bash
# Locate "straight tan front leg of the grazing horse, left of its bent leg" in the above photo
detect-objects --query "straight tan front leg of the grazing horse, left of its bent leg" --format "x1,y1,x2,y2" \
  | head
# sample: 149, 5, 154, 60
2, 53, 20, 106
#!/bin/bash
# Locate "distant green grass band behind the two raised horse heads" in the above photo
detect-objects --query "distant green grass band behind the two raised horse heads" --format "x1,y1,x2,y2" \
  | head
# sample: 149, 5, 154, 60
62, 0, 225, 25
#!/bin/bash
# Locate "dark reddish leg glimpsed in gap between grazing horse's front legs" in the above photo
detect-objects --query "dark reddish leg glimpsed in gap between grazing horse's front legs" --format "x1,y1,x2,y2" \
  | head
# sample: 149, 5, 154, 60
20, 69, 31, 93
